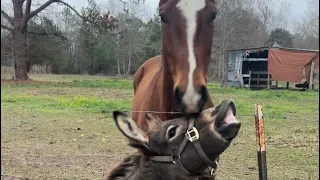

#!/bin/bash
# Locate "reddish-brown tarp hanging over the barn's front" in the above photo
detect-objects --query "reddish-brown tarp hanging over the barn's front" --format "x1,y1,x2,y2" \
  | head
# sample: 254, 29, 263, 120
268, 48, 319, 83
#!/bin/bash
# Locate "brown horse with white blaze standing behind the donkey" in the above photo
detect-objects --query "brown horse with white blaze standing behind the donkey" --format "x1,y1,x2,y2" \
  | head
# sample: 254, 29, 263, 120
132, 0, 216, 129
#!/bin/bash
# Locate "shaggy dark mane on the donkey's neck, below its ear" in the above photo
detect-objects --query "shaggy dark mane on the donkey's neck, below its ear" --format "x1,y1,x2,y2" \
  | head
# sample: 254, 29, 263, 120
107, 153, 142, 180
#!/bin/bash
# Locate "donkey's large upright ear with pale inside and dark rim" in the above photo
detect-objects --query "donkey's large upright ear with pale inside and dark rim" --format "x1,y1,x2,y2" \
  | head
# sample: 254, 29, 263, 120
113, 111, 148, 148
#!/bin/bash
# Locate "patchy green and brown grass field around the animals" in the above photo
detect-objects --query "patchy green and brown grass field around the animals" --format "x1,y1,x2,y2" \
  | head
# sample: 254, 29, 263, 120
1, 75, 319, 180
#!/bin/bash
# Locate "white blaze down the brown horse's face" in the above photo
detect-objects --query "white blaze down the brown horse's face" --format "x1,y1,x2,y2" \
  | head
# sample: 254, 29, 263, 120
177, 0, 206, 106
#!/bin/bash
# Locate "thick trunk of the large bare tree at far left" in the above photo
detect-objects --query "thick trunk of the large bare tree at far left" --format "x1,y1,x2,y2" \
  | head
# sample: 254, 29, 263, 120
12, 28, 29, 80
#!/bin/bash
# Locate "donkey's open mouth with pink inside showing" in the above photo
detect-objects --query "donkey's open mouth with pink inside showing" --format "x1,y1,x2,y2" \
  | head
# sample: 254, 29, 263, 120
215, 100, 241, 141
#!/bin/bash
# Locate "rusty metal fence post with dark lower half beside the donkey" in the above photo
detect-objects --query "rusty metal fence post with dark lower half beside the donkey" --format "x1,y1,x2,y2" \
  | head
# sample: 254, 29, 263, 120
254, 104, 268, 180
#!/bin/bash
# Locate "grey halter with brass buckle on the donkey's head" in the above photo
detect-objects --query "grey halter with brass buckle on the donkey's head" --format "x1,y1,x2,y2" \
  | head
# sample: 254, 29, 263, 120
150, 118, 218, 177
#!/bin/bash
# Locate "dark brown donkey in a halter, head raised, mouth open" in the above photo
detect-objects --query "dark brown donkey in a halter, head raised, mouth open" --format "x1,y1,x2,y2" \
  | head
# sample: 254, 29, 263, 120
107, 100, 240, 180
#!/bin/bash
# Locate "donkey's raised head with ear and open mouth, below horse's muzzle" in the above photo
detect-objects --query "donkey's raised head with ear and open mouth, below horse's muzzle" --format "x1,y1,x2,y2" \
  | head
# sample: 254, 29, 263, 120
113, 100, 240, 178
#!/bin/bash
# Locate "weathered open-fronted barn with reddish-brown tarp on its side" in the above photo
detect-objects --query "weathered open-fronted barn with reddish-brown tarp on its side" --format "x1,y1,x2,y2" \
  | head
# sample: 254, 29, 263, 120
227, 43, 319, 89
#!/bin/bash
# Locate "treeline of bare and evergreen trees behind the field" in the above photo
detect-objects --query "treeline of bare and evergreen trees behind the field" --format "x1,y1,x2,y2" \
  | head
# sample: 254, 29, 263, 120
1, 0, 319, 79
